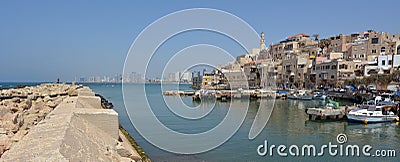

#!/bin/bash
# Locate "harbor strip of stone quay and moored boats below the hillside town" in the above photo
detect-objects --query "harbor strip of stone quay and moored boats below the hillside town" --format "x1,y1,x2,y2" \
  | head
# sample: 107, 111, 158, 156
163, 85, 400, 124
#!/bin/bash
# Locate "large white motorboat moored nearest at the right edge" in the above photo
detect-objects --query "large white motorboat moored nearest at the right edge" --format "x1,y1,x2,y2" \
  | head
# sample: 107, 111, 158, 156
347, 106, 399, 124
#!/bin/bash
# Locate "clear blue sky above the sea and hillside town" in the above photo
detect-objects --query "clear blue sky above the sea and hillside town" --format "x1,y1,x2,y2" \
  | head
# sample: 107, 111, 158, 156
0, 0, 400, 81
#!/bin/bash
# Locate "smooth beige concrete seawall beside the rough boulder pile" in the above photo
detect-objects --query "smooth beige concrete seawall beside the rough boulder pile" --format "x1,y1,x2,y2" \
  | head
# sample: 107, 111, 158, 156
0, 87, 142, 161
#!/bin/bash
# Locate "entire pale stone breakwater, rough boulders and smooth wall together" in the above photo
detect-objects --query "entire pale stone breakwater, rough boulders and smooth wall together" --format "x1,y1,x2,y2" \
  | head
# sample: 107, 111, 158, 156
0, 84, 142, 161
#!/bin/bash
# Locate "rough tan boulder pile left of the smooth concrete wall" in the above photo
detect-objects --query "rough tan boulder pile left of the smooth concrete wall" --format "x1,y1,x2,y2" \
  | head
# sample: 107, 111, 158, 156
0, 84, 77, 156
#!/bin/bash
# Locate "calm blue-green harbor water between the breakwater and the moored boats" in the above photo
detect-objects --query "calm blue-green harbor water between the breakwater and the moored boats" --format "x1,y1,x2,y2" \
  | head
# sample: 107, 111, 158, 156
2, 84, 400, 161
